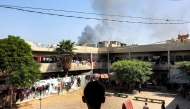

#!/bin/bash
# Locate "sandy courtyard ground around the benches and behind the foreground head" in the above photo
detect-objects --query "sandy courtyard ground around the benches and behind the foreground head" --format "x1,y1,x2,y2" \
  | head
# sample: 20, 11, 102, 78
5, 89, 190, 109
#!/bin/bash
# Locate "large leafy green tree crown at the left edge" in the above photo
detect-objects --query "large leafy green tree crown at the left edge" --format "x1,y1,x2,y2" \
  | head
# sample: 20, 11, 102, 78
0, 35, 41, 86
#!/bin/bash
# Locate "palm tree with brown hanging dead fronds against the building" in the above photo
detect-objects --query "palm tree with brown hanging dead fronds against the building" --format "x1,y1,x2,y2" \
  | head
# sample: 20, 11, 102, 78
56, 40, 76, 77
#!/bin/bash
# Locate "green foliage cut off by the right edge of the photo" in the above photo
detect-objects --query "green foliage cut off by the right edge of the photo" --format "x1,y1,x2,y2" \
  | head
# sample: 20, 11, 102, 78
174, 61, 190, 75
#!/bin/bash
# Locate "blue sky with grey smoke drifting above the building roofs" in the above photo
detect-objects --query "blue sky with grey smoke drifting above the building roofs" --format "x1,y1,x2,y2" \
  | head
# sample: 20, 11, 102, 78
0, 0, 190, 45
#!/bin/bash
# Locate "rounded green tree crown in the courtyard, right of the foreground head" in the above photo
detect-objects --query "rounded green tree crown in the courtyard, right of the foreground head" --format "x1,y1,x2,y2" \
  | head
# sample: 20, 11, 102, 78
110, 60, 153, 82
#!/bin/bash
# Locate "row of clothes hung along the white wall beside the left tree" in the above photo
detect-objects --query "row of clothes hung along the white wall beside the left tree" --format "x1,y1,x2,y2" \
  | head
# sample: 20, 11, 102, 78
0, 76, 81, 105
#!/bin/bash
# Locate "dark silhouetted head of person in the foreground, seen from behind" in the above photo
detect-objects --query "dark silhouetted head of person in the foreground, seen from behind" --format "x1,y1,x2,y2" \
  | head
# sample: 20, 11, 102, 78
82, 81, 105, 109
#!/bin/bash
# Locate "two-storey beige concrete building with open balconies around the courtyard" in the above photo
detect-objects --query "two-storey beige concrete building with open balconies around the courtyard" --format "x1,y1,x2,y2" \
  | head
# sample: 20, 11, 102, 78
0, 34, 190, 84
